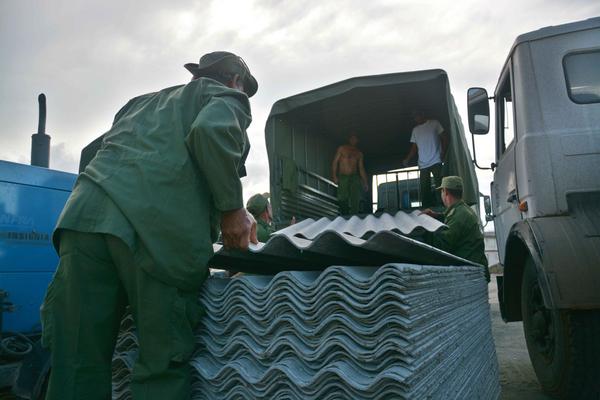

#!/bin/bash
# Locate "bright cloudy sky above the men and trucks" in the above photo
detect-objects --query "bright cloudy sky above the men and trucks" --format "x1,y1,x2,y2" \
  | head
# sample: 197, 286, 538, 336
0, 0, 600, 206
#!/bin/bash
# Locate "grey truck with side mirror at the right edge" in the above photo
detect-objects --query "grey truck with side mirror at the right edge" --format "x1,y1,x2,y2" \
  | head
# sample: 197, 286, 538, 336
467, 18, 600, 399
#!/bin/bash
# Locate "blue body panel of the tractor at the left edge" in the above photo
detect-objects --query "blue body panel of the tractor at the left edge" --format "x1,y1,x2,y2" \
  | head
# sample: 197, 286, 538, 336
0, 161, 77, 332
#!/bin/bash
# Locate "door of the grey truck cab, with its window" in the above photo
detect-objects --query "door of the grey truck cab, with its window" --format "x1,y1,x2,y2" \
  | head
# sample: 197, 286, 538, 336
491, 61, 521, 264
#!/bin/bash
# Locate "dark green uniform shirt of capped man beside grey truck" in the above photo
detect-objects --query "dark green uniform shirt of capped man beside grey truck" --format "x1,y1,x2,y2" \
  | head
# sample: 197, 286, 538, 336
432, 200, 490, 282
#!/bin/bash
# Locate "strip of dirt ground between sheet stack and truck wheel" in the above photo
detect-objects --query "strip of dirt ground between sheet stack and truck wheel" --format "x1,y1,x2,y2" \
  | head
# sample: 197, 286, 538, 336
489, 275, 552, 400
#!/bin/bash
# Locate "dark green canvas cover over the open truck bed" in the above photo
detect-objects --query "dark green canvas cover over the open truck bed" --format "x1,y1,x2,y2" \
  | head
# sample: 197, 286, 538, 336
265, 69, 479, 221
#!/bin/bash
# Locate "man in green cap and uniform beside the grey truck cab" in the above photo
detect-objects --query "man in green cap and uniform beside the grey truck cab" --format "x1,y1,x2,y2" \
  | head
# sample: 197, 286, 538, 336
423, 176, 490, 282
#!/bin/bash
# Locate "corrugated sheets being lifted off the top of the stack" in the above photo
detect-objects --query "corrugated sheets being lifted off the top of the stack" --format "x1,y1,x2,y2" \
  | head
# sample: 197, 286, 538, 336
209, 211, 474, 274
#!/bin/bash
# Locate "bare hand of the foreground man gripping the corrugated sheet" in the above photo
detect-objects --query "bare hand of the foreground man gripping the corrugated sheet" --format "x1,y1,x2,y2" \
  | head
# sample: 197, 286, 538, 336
221, 208, 258, 250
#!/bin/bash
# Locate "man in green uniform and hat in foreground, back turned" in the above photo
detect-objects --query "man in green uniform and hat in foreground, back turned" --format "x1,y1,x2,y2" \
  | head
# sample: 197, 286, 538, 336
42, 52, 258, 400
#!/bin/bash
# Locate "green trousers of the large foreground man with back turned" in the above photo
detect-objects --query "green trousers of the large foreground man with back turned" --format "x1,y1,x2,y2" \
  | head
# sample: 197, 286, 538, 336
42, 230, 202, 400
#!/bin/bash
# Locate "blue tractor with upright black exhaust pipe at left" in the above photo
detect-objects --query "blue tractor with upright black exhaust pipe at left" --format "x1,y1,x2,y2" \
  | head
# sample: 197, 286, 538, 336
0, 94, 77, 399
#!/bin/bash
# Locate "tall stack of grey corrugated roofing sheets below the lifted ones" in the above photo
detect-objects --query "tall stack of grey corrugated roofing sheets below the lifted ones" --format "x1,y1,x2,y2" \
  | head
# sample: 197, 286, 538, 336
114, 264, 499, 400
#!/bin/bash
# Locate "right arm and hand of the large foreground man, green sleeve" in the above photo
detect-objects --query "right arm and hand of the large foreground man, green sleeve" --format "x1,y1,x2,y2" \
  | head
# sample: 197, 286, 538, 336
185, 96, 255, 249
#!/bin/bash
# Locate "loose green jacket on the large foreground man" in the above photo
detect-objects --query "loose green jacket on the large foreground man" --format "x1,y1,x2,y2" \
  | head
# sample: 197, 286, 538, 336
54, 78, 251, 290
